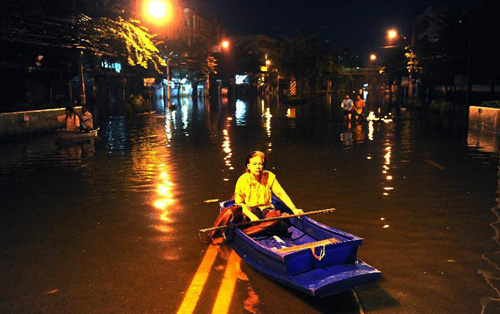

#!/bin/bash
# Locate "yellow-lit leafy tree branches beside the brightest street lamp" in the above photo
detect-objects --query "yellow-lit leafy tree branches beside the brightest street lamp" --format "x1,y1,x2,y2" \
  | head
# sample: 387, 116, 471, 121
81, 17, 166, 73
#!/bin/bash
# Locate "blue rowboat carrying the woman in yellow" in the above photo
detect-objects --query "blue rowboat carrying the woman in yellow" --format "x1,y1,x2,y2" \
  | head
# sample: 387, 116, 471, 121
220, 198, 381, 297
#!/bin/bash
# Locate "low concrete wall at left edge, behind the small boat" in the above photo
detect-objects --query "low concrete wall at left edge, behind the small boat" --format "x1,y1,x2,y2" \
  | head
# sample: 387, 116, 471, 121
0, 107, 82, 140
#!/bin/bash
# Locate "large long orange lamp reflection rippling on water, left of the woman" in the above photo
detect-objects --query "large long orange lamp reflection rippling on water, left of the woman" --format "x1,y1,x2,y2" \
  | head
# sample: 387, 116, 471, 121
124, 118, 184, 260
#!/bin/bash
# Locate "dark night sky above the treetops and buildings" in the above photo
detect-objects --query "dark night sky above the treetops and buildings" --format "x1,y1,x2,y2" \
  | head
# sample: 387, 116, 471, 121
193, 0, 478, 58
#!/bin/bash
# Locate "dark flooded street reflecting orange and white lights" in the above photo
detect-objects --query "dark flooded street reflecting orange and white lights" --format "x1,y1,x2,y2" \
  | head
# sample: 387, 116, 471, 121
0, 98, 500, 313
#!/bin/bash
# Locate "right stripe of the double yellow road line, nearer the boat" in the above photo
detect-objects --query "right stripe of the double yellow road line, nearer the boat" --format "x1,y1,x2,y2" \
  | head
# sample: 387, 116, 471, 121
212, 251, 241, 314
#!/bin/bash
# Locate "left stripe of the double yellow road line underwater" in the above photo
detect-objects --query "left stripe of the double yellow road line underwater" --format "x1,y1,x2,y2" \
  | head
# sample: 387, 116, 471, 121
177, 245, 219, 314
